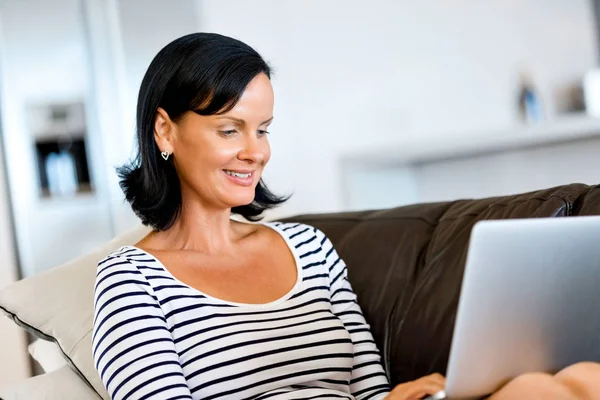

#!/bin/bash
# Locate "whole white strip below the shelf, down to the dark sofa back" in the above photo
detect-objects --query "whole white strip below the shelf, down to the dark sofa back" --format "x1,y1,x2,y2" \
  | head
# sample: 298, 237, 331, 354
344, 134, 600, 210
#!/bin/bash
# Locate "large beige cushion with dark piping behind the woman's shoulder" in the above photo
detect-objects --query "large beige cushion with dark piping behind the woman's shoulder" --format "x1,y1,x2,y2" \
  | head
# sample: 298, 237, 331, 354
0, 226, 150, 400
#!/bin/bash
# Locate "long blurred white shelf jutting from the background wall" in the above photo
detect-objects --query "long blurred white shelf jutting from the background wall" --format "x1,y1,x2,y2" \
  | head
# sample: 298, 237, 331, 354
343, 115, 600, 166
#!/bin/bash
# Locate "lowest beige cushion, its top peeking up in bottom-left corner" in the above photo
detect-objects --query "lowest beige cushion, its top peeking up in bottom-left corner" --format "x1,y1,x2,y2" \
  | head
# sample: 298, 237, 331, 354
0, 365, 100, 400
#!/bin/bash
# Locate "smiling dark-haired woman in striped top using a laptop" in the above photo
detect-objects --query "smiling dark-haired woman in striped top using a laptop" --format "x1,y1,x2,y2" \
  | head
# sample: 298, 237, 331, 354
93, 33, 587, 400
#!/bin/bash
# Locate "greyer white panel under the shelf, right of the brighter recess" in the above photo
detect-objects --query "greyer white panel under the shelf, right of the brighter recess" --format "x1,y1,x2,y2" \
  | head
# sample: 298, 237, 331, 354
413, 135, 600, 202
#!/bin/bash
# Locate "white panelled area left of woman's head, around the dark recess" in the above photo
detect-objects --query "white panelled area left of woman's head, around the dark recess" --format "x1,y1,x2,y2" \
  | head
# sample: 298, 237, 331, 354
0, 0, 197, 276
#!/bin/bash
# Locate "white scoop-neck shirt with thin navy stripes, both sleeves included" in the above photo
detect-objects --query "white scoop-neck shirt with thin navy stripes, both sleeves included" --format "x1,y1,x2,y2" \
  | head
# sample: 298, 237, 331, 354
92, 222, 389, 400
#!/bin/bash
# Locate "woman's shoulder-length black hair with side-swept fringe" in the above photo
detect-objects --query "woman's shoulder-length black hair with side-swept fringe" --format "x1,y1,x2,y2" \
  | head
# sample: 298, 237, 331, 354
117, 33, 287, 230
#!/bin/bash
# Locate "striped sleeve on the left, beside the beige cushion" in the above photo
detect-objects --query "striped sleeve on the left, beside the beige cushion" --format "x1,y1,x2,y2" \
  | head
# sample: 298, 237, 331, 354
92, 256, 192, 400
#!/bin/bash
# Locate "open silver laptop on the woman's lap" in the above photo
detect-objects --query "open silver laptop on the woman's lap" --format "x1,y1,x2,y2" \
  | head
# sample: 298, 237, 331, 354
428, 216, 600, 400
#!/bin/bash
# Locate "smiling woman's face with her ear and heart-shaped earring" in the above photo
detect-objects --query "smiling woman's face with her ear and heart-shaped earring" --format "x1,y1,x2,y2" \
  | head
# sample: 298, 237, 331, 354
155, 74, 274, 208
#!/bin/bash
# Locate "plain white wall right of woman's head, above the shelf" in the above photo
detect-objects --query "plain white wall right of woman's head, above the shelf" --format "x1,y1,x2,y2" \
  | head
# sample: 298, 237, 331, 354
197, 0, 597, 217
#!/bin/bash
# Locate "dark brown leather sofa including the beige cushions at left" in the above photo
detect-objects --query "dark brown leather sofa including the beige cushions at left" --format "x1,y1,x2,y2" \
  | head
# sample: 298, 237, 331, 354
0, 184, 600, 400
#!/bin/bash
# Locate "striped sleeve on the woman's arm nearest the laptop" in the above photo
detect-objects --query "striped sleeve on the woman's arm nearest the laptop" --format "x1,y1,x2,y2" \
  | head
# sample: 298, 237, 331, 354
323, 231, 390, 400
